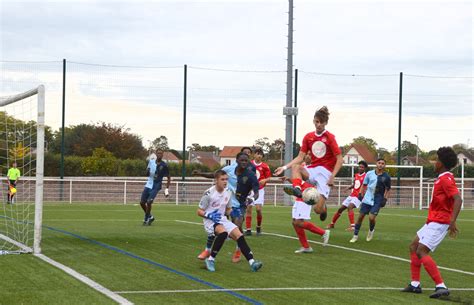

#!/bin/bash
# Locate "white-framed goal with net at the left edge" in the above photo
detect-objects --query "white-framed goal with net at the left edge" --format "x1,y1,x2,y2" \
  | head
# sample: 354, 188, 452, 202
0, 85, 45, 254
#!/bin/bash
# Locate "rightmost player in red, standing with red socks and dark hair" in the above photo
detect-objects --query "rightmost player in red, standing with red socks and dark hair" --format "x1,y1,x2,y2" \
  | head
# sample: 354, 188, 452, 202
402, 147, 462, 299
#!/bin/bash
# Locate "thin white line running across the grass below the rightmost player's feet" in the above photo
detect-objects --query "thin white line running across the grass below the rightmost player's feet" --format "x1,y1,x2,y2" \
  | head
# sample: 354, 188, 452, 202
114, 287, 474, 294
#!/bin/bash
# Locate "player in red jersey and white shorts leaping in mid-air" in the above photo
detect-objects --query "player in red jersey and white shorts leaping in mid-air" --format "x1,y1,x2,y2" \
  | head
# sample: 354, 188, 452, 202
274, 106, 342, 221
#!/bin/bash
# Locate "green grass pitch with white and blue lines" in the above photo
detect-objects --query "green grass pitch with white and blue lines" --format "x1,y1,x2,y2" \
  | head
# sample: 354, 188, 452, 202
0, 204, 474, 305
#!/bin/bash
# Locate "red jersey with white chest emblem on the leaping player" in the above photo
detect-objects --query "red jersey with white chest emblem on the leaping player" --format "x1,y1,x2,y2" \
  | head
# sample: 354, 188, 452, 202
301, 130, 341, 172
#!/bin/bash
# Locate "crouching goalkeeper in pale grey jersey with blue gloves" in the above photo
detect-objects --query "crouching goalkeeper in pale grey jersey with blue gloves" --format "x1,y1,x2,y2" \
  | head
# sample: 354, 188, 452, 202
197, 170, 263, 272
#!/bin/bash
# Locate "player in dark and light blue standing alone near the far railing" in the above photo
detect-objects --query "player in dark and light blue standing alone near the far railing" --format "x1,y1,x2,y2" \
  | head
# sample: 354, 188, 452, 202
140, 149, 171, 226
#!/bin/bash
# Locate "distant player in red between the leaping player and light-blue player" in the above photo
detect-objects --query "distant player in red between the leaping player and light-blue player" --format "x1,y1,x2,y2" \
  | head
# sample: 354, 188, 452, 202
327, 161, 369, 231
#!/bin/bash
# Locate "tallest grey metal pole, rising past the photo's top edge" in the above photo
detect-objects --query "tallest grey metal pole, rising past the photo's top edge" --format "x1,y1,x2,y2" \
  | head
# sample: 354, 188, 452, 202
285, 0, 293, 167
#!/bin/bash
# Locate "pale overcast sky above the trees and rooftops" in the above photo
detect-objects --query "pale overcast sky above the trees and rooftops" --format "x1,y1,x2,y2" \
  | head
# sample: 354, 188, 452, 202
0, 0, 474, 150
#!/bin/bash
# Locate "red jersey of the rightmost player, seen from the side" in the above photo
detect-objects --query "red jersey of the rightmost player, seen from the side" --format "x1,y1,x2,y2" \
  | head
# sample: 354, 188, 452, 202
426, 172, 459, 224
